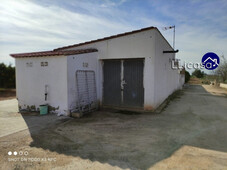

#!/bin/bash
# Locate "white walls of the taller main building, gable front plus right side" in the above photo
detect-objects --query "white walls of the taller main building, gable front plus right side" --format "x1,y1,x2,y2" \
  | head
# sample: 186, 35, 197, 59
62, 29, 184, 110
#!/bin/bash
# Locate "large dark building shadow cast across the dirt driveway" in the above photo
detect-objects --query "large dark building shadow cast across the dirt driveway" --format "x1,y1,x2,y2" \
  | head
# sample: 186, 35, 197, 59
20, 85, 227, 169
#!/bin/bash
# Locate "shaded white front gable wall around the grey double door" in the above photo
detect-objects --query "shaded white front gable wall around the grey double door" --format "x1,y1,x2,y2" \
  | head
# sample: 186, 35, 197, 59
65, 30, 155, 110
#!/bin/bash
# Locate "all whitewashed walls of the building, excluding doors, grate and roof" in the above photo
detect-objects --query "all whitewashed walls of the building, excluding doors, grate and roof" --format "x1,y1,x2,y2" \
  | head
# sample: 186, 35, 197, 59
16, 29, 184, 114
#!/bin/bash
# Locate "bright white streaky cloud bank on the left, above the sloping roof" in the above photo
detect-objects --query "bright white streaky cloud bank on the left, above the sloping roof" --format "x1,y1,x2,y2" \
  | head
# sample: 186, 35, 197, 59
0, 0, 131, 63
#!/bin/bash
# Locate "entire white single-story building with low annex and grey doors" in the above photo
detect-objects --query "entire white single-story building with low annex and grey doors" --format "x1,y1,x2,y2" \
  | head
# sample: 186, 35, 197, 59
11, 27, 184, 115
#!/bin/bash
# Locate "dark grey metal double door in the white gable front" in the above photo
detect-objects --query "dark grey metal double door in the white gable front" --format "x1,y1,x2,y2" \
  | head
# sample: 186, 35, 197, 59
103, 59, 144, 108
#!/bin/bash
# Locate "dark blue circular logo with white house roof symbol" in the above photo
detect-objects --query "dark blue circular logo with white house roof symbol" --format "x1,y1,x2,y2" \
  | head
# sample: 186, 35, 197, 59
202, 52, 220, 70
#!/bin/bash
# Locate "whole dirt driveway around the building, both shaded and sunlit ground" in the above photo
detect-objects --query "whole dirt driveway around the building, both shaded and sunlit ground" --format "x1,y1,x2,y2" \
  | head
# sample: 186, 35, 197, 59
0, 85, 227, 170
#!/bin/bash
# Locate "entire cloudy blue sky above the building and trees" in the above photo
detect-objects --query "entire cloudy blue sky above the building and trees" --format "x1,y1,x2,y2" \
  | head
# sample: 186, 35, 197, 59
0, 0, 227, 72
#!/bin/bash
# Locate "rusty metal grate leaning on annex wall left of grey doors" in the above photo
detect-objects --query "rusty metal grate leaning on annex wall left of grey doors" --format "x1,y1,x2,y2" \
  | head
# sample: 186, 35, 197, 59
76, 70, 98, 113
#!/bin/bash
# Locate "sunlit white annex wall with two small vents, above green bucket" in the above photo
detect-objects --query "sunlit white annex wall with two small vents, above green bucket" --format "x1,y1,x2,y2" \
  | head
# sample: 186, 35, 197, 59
16, 56, 68, 114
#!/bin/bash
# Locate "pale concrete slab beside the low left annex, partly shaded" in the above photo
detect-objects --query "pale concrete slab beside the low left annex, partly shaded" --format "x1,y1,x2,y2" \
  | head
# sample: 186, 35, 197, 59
0, 99, 70, 137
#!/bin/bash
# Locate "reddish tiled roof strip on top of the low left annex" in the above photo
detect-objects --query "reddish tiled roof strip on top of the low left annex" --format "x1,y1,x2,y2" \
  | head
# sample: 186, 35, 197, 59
10, 48, 98, 58
